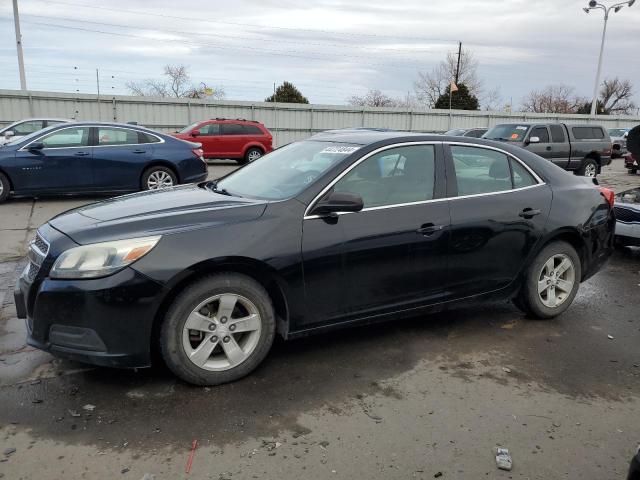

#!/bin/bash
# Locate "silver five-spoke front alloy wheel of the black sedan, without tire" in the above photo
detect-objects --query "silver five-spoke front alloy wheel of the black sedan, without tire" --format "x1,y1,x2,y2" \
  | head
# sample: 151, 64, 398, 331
182, 293, 262, 372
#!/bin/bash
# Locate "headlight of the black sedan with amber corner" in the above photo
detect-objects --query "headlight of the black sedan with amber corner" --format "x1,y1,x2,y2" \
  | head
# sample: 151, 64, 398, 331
49, 236, 161, 278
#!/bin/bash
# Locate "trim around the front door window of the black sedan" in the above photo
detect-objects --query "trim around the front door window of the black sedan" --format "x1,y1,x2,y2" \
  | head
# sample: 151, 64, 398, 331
303, 141, 449, 220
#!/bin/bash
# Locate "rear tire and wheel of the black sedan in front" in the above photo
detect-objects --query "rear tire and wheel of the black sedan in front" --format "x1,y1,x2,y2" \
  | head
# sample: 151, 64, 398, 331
514, 241, 582, 319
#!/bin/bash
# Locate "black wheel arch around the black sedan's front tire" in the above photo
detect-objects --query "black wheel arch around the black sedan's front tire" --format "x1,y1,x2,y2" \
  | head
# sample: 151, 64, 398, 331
151, 259, 289, 351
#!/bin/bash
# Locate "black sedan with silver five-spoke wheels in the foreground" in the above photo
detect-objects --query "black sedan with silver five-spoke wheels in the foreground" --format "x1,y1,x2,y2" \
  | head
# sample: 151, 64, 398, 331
15, 130, 615, 385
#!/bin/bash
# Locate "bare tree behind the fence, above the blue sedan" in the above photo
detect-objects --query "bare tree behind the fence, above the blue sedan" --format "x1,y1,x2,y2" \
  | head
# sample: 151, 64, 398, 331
126, 65, 225, 100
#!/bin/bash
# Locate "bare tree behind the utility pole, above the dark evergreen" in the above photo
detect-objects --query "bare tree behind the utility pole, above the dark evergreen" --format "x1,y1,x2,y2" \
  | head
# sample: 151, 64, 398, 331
413, 48, 482, 107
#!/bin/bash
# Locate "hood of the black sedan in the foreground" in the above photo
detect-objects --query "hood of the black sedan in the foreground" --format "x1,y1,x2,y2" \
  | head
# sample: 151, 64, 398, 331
49, 185, 267, 245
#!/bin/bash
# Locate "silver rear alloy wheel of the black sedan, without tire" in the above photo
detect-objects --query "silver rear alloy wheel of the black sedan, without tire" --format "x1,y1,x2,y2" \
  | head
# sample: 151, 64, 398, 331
538, 253, 576, 308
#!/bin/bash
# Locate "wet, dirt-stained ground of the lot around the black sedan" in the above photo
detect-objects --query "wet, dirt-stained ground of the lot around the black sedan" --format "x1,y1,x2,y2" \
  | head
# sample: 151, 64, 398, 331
0, 161, 640, 480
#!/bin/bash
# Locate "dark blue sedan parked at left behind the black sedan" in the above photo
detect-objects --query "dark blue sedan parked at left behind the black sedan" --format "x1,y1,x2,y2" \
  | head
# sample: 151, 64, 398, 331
0, 122, 207, 202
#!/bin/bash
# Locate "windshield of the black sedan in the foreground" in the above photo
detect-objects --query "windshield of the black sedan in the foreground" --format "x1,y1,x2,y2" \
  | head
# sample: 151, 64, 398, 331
216, 140, 361, 200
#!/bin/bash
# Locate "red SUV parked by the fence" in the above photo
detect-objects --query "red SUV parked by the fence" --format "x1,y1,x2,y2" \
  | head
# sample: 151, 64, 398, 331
172, 118, 273, 163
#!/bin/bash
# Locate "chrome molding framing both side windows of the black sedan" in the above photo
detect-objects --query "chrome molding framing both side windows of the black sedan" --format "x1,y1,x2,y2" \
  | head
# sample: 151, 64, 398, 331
303, 141, 546, 220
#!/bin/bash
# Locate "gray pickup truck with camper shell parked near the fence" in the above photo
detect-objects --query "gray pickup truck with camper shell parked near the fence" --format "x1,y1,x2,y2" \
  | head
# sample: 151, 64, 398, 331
482, 123, 612, 177
